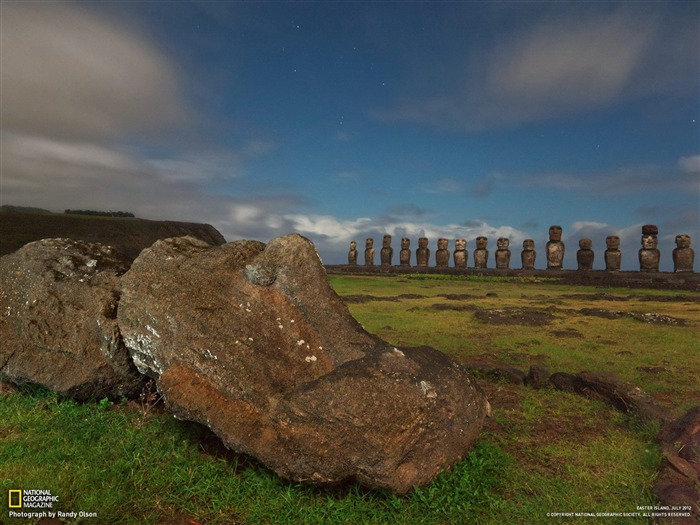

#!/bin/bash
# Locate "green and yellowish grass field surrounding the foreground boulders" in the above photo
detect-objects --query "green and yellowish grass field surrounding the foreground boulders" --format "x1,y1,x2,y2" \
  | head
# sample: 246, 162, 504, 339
0, 276, 700, 525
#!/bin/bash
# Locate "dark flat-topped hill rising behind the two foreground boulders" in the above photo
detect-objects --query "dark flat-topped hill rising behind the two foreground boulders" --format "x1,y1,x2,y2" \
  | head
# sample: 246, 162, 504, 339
0, 211, 226, 260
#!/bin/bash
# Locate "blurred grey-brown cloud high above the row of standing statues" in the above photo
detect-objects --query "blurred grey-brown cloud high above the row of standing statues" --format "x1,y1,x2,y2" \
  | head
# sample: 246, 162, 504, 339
376, 4, 700, 131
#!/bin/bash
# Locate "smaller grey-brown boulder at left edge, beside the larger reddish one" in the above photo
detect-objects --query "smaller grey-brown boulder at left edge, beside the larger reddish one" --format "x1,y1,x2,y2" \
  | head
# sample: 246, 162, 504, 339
0, 239, 142, 399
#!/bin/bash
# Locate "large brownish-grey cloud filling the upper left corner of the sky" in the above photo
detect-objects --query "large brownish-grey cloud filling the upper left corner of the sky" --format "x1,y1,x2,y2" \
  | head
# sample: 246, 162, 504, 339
0, 2, 189, 140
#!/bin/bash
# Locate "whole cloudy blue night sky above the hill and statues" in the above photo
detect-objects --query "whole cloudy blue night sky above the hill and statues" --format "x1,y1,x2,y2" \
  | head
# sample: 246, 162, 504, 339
0, 1, 700, 271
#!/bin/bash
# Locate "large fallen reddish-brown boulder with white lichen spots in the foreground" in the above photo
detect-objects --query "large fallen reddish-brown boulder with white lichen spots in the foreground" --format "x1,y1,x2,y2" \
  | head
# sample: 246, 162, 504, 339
118, 235, 488, 493
